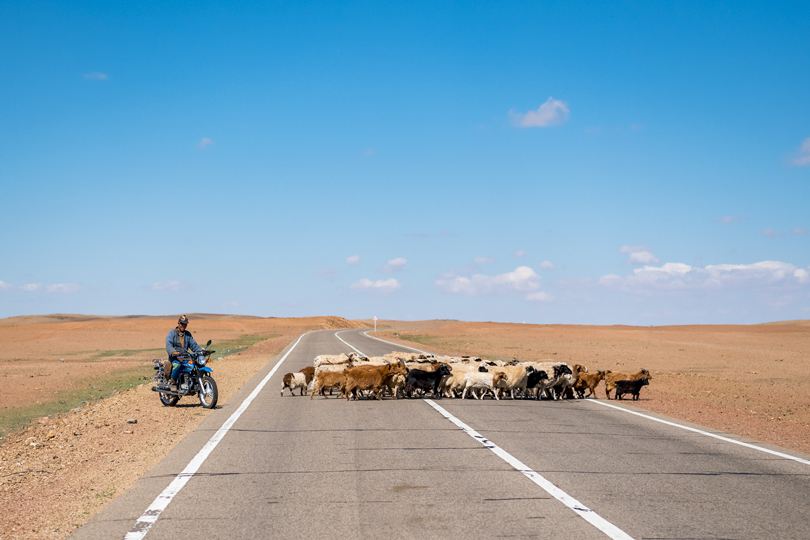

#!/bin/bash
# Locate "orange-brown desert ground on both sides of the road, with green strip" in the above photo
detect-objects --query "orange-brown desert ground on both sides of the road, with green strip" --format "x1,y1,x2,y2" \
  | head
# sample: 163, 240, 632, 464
0, 314, 810, 540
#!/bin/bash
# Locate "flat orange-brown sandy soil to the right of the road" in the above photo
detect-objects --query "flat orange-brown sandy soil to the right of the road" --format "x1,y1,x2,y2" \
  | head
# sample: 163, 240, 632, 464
379, 321, 810, 453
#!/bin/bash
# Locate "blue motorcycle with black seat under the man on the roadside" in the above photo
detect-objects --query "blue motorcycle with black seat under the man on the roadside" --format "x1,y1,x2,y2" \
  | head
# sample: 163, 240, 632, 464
152, 339, 219, 409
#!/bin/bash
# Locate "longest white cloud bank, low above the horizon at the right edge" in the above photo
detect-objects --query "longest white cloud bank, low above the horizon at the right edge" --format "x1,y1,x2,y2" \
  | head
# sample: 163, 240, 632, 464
599, 261, 810, 294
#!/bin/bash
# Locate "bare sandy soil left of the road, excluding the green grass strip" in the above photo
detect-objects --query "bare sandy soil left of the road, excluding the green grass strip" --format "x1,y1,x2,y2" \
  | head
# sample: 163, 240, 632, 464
0, 315, 358, 540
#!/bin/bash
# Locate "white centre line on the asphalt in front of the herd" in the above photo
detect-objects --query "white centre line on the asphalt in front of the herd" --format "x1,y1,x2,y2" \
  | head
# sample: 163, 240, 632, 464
423, 399, 633, 540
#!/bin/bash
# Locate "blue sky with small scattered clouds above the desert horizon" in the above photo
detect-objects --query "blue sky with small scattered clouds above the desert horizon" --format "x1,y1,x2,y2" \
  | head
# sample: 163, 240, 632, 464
0, 1, 810, 325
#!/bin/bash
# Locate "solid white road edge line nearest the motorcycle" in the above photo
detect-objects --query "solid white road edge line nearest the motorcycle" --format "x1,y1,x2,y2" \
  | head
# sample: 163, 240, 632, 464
124, 332, 311, 540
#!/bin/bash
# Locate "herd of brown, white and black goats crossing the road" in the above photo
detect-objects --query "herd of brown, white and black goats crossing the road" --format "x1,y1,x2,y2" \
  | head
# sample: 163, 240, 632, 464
281, 352, 652, 400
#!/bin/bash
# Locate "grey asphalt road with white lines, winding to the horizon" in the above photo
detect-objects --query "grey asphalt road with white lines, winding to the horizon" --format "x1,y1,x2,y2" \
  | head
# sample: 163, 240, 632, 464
71, 330, 810, 540
